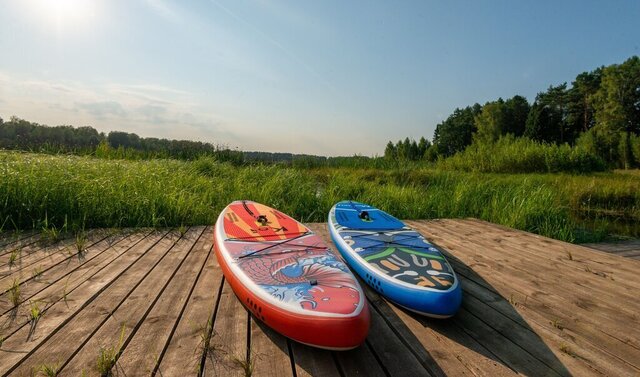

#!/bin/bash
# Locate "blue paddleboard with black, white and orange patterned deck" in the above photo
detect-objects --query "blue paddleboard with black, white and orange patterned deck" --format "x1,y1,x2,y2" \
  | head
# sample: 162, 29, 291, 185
329, 201, 462, 318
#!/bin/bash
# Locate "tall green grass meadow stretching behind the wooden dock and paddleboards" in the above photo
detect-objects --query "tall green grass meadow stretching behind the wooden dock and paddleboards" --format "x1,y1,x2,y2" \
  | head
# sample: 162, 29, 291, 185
0, 151, 640, 242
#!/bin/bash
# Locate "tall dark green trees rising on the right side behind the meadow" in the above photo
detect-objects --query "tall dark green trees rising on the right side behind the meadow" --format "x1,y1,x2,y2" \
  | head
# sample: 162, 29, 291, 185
384, 56, 640, 167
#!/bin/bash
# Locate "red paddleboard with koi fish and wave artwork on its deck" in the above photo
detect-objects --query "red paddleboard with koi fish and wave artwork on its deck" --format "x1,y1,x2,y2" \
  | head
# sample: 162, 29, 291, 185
214, 201, 369, 350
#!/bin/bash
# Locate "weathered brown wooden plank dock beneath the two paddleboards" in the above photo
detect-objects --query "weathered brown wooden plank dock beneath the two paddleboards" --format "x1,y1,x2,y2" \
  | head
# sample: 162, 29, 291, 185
0, 220, 640, 376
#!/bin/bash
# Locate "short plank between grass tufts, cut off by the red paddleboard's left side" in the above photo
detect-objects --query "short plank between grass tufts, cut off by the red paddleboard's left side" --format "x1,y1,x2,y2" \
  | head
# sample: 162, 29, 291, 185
202, 280, 249, 376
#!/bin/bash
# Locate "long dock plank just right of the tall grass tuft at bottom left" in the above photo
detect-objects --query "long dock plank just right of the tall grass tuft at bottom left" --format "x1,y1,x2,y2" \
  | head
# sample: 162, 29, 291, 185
110, 227, 213, 376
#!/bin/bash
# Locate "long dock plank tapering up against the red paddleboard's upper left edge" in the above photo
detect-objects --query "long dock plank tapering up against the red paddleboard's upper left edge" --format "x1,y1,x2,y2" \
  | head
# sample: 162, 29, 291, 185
157, 229, 222, 376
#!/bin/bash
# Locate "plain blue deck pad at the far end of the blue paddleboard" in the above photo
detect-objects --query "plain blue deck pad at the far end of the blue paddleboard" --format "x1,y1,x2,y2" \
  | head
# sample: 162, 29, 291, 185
335, 201, 405, 230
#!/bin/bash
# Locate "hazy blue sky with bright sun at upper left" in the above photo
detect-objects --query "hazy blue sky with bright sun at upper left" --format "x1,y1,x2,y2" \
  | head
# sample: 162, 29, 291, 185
0, 0, 640, 156
